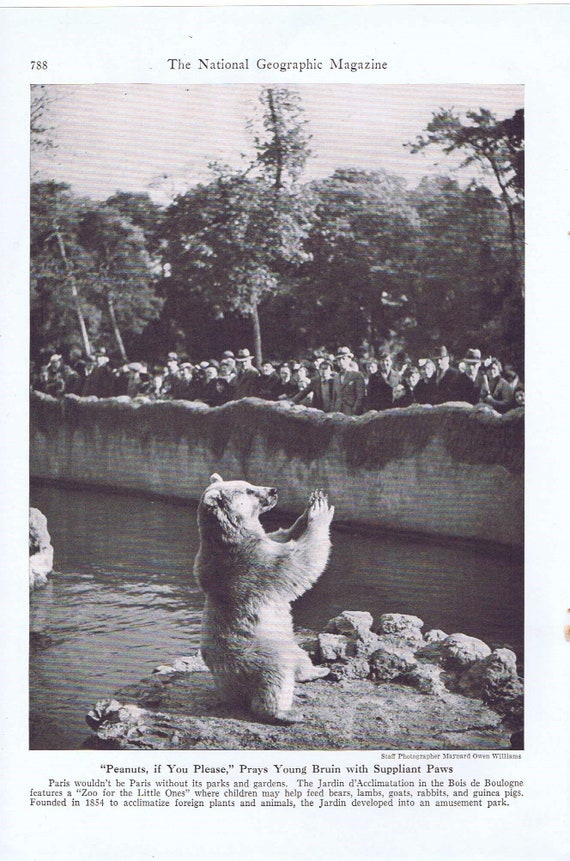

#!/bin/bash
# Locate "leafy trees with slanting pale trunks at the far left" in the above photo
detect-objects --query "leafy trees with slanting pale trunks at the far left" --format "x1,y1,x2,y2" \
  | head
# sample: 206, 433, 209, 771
31, 182, 161, 358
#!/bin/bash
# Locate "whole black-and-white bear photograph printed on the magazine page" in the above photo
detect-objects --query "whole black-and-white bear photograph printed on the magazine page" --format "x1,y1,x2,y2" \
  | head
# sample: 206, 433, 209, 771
30, 84, 525, 751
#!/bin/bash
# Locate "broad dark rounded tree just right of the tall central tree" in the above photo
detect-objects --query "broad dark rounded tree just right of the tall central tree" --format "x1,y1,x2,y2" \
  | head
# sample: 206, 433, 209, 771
296, 169, 417, 346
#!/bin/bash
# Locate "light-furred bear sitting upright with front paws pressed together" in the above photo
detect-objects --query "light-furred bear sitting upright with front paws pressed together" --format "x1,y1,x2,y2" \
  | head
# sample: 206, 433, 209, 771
194, 473, 334, 723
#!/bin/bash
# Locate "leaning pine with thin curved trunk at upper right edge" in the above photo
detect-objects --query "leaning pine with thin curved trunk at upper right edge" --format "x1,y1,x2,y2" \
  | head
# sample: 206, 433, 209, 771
407, 108, 524, 290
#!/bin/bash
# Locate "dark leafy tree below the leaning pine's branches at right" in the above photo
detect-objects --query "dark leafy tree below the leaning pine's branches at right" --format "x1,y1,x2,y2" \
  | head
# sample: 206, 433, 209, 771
405, 177, 520, 361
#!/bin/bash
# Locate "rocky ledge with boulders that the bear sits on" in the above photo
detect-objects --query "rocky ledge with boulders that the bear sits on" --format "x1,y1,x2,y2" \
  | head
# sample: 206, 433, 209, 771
86, 611, 523, 750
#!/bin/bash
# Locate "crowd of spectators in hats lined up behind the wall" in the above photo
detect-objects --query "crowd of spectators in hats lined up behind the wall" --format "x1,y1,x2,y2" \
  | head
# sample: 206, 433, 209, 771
32, 346, 524, 416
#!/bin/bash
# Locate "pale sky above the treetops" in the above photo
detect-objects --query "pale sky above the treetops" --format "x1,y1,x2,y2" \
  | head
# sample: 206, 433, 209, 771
32, 84, 523, 203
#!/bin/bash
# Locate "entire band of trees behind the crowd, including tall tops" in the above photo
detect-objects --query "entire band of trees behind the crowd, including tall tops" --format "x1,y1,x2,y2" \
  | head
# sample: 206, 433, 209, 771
31, 87, 524, 369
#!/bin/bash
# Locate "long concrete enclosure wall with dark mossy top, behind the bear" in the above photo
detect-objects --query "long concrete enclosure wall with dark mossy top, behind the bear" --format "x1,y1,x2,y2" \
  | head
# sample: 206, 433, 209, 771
30, 393, 524, 545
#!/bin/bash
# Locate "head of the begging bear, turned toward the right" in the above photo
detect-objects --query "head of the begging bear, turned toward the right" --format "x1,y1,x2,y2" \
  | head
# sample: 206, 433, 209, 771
198, 473, 277, 540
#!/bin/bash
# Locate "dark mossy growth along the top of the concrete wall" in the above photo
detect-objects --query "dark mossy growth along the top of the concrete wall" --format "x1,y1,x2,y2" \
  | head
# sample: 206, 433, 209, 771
32, 393, 524, 473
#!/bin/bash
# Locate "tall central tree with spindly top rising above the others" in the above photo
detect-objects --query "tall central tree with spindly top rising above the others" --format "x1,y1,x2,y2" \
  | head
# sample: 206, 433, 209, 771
160, 88, 312, 364
